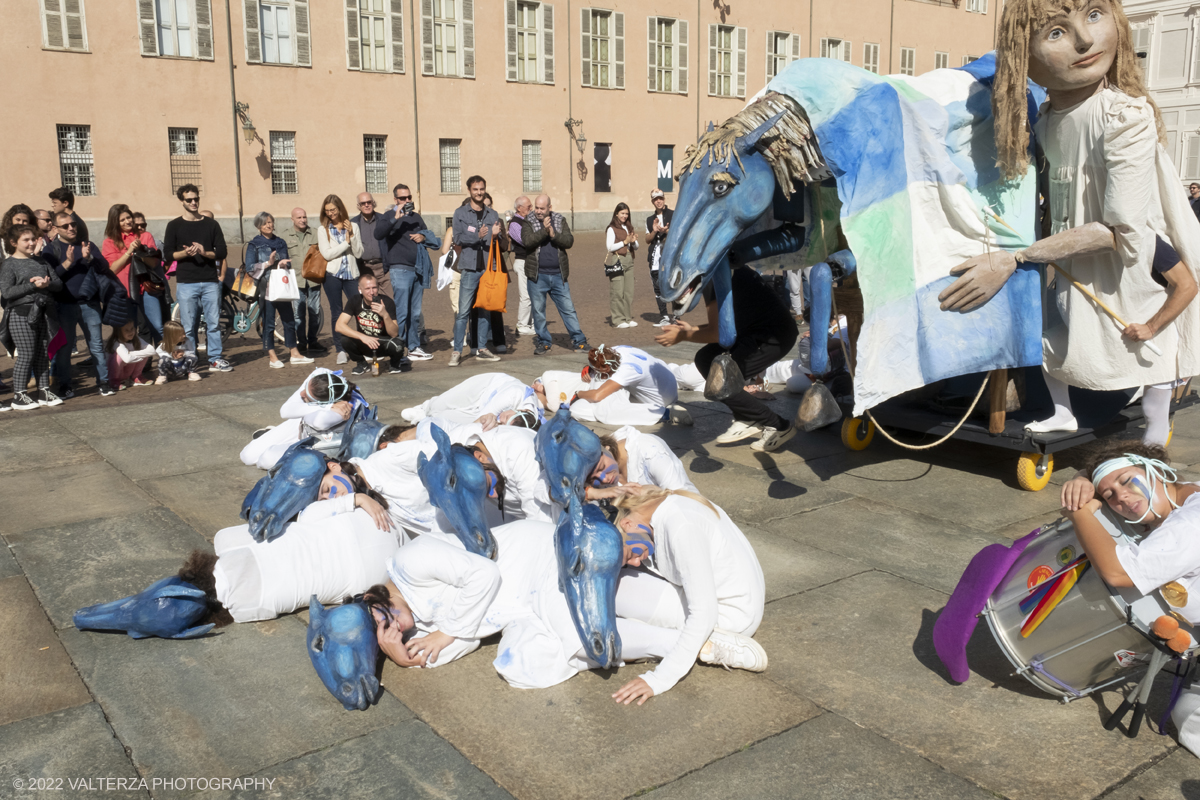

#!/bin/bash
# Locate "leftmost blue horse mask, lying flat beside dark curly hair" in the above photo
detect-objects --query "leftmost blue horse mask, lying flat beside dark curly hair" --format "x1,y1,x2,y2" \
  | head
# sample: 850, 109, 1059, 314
74, 575, 214, 639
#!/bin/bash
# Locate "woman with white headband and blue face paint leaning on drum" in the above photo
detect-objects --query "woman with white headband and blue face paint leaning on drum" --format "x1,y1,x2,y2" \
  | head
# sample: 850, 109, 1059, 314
1063, 443, 1200, 756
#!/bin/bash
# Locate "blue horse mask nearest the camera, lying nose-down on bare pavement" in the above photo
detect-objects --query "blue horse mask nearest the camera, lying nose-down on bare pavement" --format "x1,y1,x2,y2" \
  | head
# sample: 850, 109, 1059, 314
307, 595, 383, 711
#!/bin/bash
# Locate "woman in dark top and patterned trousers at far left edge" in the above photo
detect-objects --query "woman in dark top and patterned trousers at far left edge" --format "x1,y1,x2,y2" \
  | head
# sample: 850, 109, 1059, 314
0, 225, 62, 411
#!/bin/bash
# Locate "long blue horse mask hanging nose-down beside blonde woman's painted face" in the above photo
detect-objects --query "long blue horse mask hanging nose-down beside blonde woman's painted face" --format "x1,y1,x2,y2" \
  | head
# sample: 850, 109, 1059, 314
554, 498, 624, 668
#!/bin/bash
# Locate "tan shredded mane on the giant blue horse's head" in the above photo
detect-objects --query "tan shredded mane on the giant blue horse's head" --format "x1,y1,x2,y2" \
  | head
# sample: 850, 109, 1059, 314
680, 91, 824, 197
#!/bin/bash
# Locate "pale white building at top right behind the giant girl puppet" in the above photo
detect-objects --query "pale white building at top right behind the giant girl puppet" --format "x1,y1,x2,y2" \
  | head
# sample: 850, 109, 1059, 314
1124, 0, 1200, 184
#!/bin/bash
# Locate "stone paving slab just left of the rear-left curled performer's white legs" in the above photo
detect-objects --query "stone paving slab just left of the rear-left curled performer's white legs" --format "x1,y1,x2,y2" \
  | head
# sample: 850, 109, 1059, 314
89, 417, 253, 481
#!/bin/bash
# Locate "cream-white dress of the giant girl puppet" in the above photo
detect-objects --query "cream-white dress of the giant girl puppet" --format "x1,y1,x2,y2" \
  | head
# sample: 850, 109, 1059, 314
1034, 88, 1200, 390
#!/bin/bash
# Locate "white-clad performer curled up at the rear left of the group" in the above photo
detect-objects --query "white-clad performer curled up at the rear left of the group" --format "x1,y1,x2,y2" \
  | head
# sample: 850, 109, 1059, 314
241, 367, 367, 469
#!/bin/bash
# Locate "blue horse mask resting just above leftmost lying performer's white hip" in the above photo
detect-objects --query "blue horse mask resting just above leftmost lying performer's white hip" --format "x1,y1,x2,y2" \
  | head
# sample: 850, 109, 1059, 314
241, 438, 325, 542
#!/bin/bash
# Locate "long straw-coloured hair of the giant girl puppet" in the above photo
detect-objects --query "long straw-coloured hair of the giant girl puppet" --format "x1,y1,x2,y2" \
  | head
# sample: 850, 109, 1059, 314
991, 0, 1166, 180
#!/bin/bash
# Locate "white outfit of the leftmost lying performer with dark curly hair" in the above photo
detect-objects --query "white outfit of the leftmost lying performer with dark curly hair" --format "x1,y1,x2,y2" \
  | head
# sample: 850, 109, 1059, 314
212, 506, 398, 622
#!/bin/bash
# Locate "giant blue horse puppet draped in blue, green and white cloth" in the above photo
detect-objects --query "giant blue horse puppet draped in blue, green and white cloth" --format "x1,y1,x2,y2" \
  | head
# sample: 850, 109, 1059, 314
659, 55, 1044, 414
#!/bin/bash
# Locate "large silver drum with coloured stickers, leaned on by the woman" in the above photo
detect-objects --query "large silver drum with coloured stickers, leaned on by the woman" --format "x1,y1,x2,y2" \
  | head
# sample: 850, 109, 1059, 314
984, 513, 1195, 702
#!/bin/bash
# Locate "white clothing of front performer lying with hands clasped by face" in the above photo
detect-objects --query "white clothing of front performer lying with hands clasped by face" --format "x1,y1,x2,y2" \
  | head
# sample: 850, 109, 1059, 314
388, 521, 678, 688
